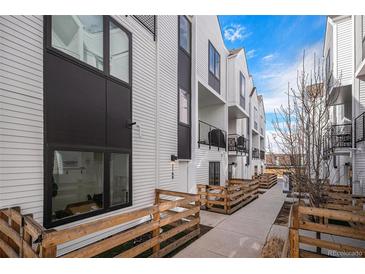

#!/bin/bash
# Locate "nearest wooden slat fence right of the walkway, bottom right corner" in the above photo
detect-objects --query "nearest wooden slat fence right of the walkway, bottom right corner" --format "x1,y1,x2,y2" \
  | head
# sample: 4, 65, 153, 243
289, 205, 365, 258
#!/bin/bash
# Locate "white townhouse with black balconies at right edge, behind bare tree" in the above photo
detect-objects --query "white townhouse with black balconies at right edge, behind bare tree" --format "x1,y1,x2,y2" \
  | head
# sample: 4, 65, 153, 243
323, 16, 365, 192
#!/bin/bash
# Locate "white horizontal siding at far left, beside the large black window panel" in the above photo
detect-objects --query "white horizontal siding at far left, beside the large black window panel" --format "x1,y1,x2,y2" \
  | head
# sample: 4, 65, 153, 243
0, 16, 43, 218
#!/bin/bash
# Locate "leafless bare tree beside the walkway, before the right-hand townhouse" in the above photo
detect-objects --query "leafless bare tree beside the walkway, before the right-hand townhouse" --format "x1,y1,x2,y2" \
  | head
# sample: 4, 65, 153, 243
273, 52, 340, 206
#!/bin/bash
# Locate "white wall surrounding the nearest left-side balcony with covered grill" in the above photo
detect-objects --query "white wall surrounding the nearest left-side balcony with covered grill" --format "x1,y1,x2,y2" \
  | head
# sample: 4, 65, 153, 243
189, 16, 228, 187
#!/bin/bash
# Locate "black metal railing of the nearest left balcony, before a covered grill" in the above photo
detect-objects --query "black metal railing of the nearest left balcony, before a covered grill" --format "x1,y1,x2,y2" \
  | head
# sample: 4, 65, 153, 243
198, 120, 227, 150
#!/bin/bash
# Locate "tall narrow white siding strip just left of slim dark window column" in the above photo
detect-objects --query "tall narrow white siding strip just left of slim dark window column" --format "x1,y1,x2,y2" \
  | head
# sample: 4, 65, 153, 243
157, 16, 180, 190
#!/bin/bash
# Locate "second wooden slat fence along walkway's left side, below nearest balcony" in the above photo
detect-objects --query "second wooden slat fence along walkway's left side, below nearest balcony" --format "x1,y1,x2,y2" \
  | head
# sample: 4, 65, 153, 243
197, 179, 259, 214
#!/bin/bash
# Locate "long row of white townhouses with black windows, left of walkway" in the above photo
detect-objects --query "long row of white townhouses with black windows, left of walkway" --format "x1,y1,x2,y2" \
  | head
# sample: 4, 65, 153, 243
0, 15, 265, 254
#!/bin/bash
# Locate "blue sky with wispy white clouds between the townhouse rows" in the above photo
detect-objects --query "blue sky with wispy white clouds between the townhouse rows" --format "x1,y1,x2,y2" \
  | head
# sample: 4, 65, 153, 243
219, 16, 326, 134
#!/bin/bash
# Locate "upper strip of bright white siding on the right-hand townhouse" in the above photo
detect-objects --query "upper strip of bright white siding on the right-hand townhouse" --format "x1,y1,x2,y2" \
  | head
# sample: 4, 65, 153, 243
336, 17, 353, 83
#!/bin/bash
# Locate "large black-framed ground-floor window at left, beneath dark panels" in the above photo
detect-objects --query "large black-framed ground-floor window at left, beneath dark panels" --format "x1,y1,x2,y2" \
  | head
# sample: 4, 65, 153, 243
45, 147, 132, 227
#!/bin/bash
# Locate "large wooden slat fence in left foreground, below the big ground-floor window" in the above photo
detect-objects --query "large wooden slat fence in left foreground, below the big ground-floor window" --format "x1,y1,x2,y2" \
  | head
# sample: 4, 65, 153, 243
0, 189, 200, 258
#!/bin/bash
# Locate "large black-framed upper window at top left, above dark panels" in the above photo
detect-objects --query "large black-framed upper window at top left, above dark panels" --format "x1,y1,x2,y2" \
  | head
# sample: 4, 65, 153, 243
51, 15, 131, 83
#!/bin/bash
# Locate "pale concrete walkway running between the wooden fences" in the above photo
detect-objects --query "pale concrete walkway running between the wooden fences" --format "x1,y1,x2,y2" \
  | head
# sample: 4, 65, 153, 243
175, 181, 286, 258
